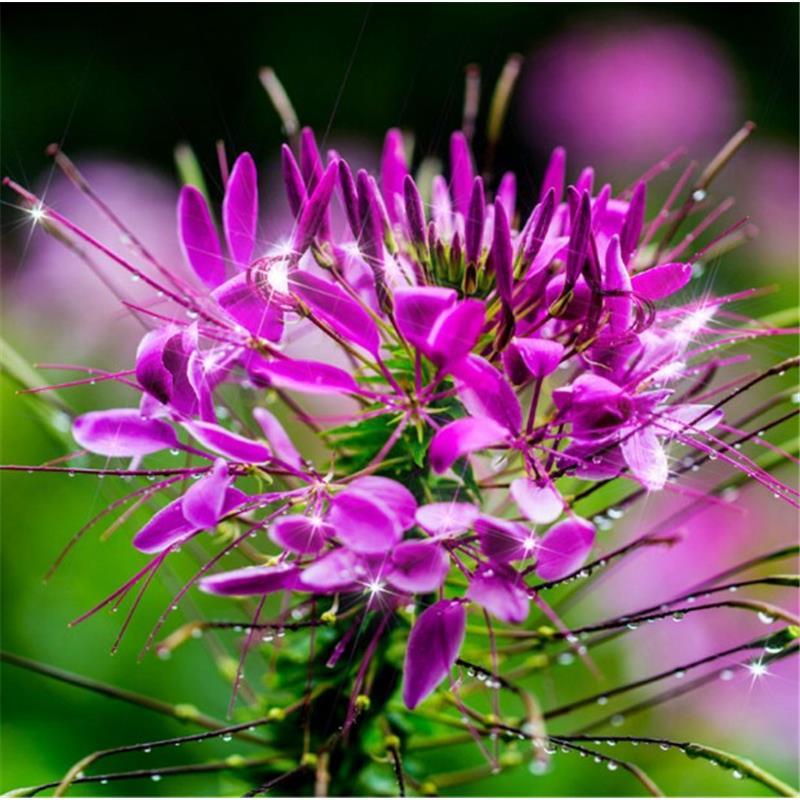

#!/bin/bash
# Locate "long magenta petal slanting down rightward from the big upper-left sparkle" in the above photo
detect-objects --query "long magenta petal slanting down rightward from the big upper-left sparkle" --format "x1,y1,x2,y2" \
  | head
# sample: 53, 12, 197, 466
289, 270, 381, 356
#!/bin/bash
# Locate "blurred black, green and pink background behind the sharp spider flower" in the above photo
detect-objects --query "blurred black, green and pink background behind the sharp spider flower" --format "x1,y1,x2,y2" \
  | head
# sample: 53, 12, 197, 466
0, 3, 798, 795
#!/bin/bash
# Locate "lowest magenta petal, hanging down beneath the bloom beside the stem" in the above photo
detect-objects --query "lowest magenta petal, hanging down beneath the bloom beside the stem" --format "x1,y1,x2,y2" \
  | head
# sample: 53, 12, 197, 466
403, 600, 467, 709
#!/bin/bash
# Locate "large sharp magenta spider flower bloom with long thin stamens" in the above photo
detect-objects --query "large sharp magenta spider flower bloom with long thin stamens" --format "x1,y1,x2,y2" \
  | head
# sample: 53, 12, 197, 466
3, 101, 797, 800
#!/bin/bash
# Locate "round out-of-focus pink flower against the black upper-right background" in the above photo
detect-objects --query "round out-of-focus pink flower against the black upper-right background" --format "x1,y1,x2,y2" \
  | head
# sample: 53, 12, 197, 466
520, 18, 739, 171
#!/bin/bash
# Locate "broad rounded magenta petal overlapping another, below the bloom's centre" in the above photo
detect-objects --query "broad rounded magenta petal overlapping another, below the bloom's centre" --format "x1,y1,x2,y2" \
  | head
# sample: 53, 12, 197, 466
328, 489, 403, 555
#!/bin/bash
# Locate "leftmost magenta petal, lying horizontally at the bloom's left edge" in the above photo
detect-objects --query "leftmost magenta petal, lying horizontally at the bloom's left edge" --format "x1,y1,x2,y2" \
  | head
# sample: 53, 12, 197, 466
72, 408, 178, 457
